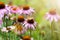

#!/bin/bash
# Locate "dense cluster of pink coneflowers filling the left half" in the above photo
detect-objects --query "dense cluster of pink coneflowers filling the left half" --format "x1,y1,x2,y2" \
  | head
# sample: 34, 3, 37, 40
0, 2, 36, 40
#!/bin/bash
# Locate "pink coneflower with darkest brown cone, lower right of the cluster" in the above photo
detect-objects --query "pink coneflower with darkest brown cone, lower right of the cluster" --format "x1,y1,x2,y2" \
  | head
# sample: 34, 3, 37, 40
24, 18, 36, 29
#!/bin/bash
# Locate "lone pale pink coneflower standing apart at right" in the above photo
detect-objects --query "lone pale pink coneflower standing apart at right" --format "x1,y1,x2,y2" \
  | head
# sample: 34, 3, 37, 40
46, 9, 60, 22
